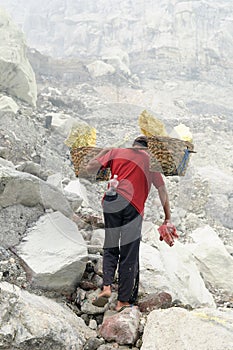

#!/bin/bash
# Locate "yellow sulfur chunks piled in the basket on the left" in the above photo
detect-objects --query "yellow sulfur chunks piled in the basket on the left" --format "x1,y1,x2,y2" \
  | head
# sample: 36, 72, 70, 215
65, 123, 96, 148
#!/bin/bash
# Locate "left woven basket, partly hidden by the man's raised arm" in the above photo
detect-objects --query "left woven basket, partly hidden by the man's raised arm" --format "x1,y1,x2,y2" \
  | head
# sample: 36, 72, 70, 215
70, 147, 110, 181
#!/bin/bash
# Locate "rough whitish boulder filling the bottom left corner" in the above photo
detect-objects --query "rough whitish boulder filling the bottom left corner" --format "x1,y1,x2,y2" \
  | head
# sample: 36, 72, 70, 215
0, 282, 96, 350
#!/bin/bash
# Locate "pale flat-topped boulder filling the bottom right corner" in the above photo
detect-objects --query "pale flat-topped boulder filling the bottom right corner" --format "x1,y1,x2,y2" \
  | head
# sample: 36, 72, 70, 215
141, 308, 233, 350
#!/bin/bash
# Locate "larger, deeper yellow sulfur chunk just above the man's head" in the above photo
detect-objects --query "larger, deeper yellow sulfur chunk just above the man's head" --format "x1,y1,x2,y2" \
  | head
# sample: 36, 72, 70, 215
138, 110, 167, 137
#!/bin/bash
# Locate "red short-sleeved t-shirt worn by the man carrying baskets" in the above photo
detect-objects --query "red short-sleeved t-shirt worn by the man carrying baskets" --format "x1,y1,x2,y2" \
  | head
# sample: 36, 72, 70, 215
97, 148, 164, 215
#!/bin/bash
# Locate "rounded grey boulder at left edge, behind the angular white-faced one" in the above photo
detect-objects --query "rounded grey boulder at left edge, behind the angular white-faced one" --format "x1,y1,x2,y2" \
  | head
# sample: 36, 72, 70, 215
0, 165, 75, 248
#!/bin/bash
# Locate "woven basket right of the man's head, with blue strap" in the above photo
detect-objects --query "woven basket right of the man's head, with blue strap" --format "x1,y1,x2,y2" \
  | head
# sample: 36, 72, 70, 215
148, 136, 194, 176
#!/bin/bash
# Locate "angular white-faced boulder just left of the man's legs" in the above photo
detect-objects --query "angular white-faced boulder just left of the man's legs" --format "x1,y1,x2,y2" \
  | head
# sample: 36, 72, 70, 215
16, 212, 88, 292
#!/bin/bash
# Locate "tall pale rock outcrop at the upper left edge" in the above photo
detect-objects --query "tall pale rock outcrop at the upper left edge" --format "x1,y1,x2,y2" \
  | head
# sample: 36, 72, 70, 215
0, 8, 37, 108
